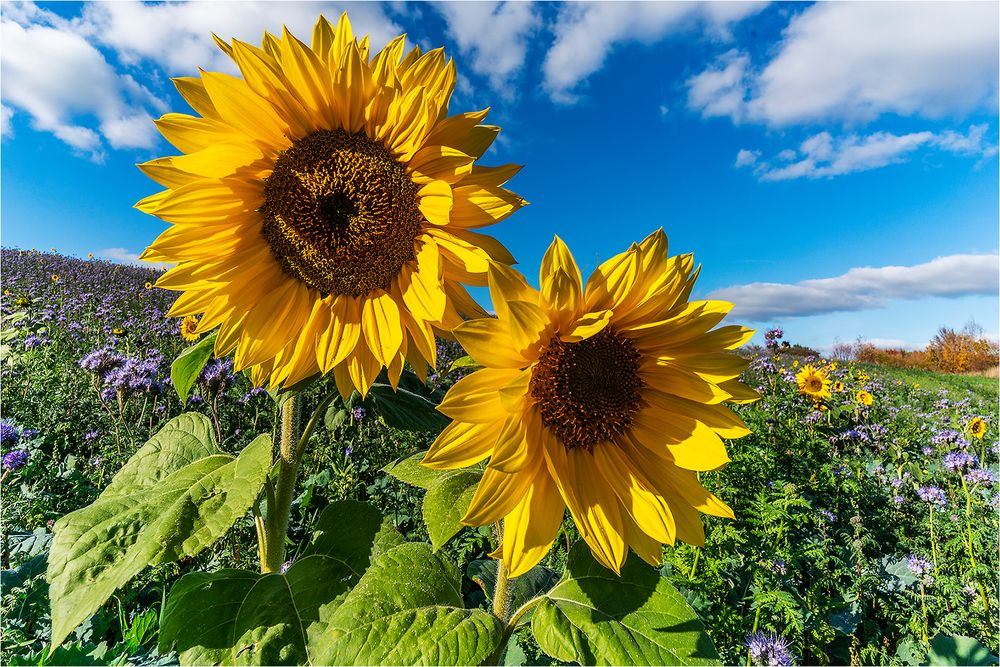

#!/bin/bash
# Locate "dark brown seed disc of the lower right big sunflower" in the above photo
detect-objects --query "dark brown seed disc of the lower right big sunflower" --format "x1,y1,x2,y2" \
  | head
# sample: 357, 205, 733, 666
529, 328, 645, 450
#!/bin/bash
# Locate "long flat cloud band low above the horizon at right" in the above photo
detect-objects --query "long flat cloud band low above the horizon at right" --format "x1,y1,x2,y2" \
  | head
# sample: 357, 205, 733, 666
708, 255, 1000, 322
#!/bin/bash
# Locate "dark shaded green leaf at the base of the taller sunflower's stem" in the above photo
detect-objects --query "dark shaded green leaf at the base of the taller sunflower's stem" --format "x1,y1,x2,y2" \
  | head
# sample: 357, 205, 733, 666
160, 500, 403, 665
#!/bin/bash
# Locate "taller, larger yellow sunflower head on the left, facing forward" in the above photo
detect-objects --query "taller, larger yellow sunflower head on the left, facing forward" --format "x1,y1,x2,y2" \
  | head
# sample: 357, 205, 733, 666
136, 14, 525, 395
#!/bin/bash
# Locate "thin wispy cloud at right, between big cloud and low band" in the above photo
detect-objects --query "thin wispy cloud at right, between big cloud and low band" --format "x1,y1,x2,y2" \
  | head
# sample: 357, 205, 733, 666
735, 124, 997, 181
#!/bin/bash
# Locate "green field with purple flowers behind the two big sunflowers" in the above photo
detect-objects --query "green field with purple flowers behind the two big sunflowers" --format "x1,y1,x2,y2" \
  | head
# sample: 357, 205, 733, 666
0, 249, 1000, 665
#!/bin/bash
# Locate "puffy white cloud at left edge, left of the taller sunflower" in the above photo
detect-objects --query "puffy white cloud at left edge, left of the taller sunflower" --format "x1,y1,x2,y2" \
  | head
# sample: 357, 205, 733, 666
0, 6, 164, 161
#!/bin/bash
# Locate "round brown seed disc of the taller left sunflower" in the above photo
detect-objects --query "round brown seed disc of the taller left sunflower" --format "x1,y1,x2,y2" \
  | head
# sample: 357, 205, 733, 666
260, 130, 423, 297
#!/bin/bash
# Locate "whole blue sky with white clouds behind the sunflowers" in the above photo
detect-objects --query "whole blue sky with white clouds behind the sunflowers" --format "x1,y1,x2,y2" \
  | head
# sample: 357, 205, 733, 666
0, 2, 1000, 349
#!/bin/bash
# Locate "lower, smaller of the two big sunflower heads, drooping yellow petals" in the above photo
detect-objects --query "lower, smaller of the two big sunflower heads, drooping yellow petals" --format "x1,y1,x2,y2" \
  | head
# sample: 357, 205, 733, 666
423, 230, 757, 576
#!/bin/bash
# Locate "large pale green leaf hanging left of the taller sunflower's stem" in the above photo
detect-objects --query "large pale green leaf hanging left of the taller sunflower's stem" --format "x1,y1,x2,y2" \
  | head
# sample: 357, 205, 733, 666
48, 414, 272, 646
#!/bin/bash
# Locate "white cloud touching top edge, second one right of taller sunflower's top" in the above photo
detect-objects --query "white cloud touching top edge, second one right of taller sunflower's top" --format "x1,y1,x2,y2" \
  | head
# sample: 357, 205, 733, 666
542, 2, 766, 103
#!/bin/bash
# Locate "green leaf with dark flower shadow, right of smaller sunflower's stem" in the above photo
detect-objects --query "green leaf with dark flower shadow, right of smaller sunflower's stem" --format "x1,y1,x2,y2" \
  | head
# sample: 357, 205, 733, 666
531, 542, 719, 665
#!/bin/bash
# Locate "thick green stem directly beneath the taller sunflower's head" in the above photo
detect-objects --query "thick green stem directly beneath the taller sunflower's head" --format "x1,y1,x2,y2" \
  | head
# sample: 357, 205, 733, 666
260, 396, 300, 574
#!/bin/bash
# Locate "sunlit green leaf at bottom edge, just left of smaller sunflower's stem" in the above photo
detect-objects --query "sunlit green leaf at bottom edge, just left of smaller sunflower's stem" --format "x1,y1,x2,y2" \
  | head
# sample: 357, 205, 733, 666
314, 543, 503, 665
